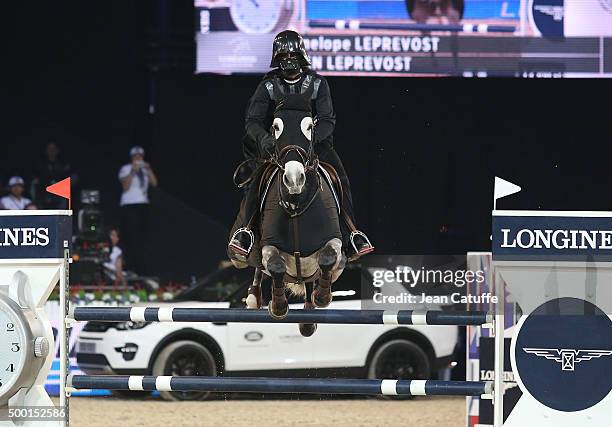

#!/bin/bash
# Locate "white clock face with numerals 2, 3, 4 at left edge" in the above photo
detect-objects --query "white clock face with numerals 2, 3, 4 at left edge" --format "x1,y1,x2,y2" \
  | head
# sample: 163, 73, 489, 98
0, 300, 27, 396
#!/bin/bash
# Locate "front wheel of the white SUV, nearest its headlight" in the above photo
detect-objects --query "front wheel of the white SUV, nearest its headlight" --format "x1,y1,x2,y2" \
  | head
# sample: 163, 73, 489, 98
153, 341, 217, 400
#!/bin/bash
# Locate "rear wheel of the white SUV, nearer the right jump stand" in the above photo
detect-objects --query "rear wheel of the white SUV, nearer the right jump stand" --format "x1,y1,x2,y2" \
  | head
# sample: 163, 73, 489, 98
368, 339, 431, 399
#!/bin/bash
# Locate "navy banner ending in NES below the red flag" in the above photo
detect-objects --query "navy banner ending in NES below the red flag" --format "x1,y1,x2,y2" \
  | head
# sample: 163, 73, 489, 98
0, 211, 72, 259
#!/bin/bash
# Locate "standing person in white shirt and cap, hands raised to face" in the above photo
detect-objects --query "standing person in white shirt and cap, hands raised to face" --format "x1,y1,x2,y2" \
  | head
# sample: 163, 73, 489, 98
119, 146, 157, 274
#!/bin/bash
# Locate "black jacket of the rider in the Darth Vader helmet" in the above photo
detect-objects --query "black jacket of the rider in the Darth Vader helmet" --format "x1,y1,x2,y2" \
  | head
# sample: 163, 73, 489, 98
245, 69, 336, 152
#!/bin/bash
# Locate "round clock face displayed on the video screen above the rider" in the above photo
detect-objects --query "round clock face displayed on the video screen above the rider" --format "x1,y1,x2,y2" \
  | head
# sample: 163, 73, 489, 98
230, 0, 285, 34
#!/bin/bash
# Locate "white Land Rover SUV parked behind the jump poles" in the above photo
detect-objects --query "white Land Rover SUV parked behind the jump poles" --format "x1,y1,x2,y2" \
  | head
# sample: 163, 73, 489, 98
77, 266, 458, 400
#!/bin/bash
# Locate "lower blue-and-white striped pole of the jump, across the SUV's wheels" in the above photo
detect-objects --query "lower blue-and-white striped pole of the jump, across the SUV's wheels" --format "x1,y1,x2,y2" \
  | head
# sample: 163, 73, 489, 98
68, 375, 493, 396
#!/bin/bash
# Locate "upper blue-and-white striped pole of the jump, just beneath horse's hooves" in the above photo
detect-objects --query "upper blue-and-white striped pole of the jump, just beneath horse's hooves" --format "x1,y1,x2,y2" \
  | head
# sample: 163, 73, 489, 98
71, 307, 494, 326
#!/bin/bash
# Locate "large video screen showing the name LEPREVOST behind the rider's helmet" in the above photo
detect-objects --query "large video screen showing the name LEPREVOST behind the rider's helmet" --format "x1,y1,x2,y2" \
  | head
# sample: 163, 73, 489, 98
195, 0, 612, 78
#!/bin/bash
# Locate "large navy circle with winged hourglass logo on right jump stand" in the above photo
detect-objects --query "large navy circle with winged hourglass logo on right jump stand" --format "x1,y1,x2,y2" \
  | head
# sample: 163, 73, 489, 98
513, 298, 612, 412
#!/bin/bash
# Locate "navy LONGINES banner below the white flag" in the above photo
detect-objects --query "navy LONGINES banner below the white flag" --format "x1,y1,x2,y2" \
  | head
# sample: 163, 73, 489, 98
492, 215, 612, 261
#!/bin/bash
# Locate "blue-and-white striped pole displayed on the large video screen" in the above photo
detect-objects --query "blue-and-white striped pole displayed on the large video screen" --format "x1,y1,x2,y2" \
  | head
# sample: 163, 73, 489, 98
308, 20, 516, 33
